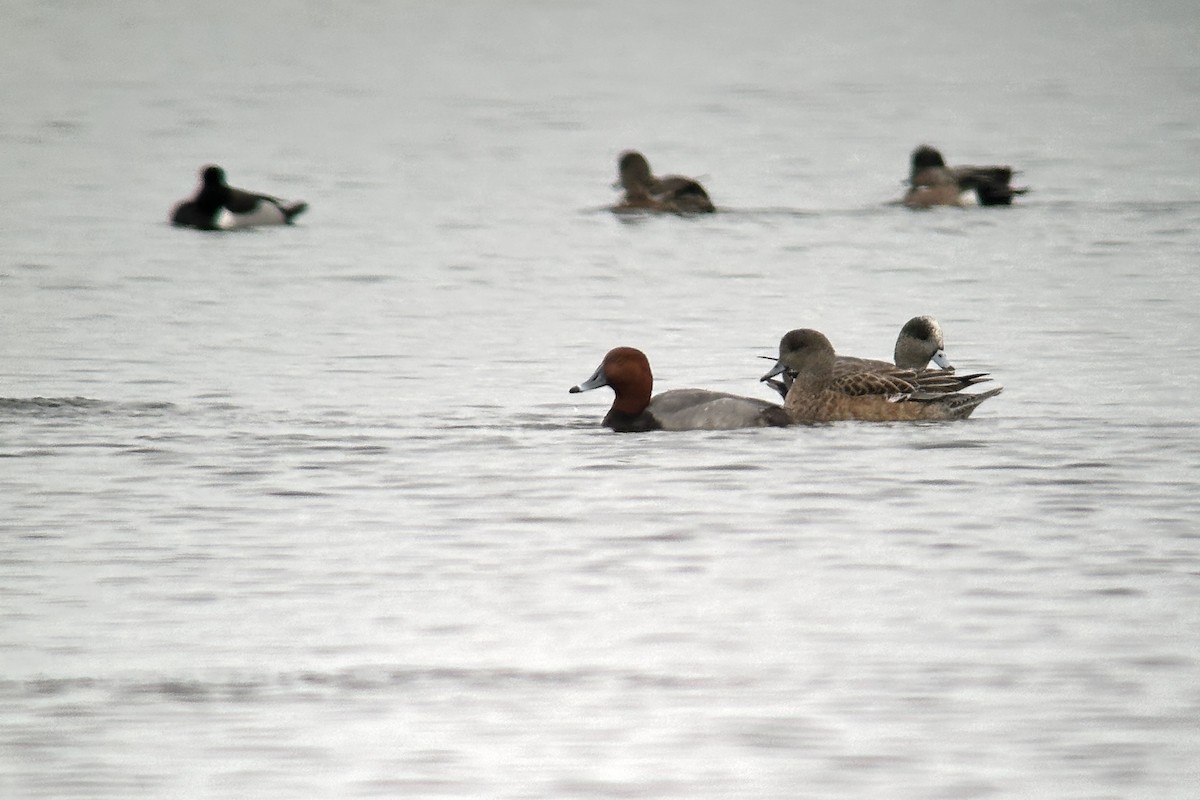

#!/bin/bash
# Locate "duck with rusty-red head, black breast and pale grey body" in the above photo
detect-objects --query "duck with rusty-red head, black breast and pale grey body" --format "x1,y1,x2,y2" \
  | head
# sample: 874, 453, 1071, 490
570, 347, 788, 433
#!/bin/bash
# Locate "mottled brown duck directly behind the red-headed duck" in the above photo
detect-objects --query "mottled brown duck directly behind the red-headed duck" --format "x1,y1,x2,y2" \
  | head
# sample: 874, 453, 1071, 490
761, 327, 1003, 422
